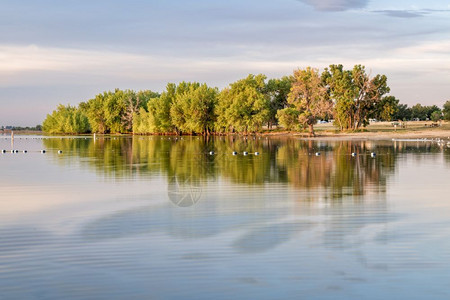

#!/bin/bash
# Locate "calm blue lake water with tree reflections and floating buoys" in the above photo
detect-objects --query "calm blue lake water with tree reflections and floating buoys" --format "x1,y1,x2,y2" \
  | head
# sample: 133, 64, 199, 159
0, 136, 450, 299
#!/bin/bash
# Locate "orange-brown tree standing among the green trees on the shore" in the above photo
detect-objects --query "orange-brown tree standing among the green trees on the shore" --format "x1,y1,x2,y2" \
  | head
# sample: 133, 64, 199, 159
288, 67, 332, 136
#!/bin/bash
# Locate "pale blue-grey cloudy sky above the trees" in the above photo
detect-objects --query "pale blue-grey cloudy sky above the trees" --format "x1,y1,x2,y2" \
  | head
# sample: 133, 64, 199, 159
0, 0, 450, 126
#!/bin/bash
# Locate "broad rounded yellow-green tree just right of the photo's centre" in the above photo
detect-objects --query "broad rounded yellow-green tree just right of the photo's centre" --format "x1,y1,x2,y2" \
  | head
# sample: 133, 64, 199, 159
216, 74, 269, 133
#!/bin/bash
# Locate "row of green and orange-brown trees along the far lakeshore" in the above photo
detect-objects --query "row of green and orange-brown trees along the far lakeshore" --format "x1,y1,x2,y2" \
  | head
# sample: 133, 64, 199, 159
42, 65, 450, 135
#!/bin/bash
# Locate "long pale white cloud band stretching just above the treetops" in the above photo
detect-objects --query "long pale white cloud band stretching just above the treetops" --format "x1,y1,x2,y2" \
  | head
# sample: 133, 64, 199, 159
0, 41, 450, 87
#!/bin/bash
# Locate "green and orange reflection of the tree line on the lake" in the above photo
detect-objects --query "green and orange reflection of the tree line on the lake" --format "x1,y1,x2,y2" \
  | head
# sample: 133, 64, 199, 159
44, 136, 414, 200
